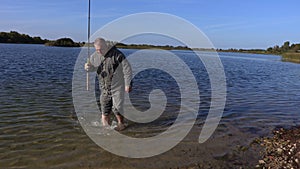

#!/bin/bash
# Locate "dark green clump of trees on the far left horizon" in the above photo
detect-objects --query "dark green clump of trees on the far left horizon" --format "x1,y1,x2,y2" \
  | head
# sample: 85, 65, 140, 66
0, 31, 48, 44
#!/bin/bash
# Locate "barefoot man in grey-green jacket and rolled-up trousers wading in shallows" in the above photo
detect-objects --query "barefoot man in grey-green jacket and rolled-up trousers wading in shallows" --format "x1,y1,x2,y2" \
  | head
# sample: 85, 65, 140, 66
85, 38, 132, 130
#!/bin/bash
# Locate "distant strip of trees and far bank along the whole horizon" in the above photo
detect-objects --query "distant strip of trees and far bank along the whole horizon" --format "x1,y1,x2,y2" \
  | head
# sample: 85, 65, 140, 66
0, 31, 300, 63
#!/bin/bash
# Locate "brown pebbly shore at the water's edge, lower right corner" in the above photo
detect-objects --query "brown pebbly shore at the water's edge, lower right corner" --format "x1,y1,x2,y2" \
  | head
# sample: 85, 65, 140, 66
175, 126, 300, 169
